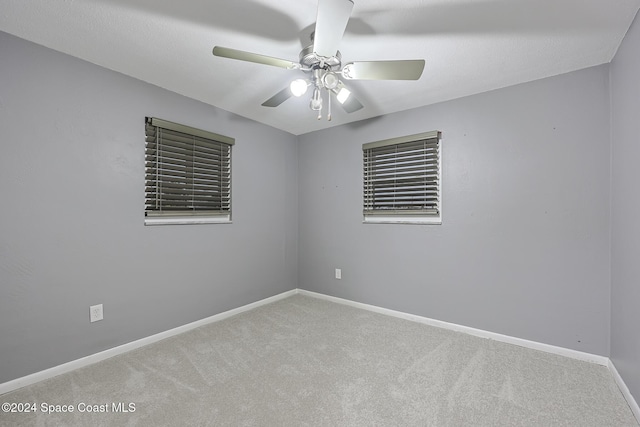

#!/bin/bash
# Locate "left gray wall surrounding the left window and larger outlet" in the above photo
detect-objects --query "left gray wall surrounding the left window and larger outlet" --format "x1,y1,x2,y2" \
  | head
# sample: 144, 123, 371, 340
0, 33, 298, 383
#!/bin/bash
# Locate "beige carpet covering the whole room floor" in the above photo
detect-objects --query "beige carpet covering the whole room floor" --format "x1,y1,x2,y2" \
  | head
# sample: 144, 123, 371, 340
0, 295, 638, 427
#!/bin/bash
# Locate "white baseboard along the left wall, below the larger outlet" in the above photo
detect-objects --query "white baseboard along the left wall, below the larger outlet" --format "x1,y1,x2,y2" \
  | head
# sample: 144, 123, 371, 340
0, 289, 298, 395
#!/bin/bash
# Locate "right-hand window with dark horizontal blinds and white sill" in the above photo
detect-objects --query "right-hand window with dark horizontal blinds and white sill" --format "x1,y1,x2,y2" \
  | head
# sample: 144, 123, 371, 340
362, 131, 442, 224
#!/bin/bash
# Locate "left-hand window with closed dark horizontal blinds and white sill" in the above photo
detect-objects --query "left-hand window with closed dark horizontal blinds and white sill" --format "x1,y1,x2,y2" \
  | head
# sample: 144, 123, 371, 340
144, 117, 234, 225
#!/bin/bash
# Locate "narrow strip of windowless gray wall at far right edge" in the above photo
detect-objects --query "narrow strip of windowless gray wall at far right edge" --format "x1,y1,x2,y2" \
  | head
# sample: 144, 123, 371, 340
611, 12, 640, 402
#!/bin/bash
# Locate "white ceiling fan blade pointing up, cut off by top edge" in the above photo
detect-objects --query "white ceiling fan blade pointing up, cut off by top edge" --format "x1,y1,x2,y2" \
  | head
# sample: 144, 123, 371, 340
313, 0, 353, 58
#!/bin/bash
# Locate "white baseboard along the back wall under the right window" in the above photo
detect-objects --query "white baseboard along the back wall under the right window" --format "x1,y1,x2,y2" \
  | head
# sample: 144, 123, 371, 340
298, 289, 609, 366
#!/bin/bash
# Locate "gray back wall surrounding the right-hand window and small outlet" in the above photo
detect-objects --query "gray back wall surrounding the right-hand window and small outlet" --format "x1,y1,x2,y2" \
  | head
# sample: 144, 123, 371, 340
299, 65, 610, 356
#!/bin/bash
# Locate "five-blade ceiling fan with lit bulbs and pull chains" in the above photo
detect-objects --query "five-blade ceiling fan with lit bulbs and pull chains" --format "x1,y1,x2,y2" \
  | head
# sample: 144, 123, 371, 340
213, 0, 424, 120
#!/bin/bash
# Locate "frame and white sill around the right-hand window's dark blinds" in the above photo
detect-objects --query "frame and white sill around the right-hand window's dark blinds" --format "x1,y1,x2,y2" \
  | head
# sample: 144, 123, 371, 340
362, 131, 442, 225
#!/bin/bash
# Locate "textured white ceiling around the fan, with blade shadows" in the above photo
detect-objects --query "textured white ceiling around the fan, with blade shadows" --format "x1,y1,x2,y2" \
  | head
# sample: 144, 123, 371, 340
0, 0, 640, 135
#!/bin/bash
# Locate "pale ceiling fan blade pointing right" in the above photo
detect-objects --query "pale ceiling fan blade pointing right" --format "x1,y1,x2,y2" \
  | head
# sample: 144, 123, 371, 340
342, 59, 424, 80
